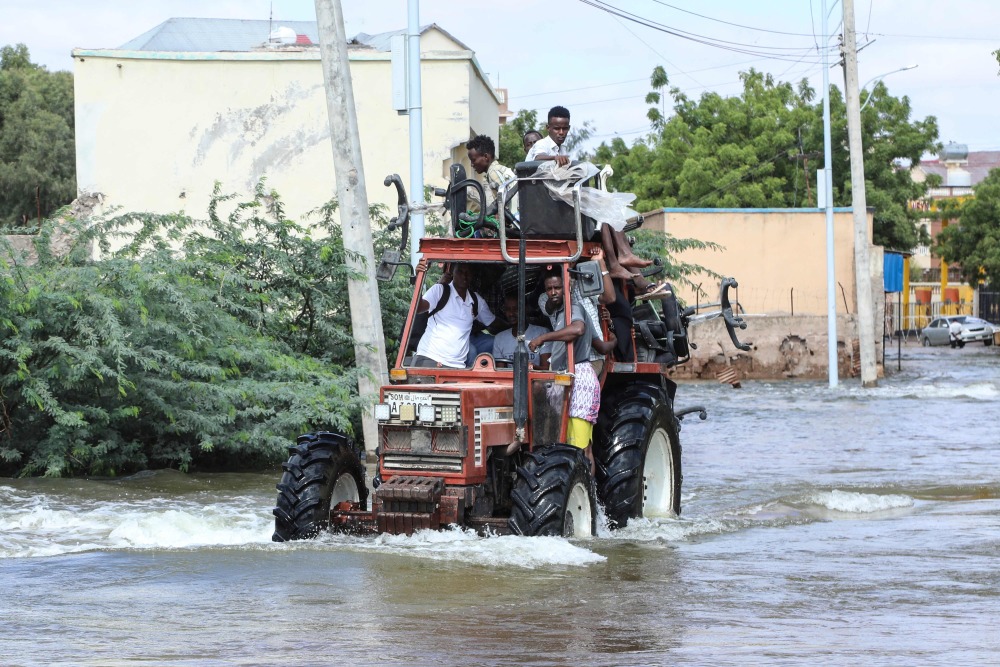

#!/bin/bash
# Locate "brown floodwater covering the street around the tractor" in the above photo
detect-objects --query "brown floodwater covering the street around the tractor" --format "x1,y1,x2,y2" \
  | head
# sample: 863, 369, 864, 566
0, 346, 1000, 666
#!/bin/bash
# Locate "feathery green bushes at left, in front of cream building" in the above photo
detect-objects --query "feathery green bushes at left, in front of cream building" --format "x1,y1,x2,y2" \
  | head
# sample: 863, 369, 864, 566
0, 185, 409, 476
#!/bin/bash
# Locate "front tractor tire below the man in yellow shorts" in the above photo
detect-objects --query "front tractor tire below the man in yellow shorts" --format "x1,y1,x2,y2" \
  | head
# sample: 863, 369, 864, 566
508, 444, 597, 537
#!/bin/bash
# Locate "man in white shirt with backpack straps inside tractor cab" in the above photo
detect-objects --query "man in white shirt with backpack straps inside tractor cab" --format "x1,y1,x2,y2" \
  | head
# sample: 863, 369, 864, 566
412, 264, 507, 368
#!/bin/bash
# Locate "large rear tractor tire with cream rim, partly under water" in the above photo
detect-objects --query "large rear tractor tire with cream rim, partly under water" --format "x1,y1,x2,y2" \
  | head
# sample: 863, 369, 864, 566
594, 382, 682, 529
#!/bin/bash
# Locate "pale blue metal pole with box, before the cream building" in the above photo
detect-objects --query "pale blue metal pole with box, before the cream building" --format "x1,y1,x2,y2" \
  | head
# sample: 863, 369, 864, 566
406, 0, 424, 266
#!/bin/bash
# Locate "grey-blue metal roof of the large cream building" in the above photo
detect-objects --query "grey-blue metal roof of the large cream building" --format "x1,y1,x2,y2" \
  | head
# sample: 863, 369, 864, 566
118, 18, 472, 53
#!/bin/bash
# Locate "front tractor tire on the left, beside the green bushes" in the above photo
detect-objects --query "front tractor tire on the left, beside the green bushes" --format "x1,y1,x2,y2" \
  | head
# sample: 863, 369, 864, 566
271, 432, 368, 542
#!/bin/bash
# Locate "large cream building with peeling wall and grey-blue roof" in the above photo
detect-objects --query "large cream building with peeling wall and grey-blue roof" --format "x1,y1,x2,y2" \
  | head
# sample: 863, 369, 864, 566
73, 19, 501, 224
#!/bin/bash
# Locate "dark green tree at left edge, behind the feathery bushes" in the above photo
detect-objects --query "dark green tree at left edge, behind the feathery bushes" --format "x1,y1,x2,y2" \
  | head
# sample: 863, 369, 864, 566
0, 44, 76, 226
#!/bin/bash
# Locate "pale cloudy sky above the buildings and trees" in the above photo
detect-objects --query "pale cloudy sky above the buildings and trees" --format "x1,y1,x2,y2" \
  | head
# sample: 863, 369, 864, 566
0, 0, 1000, 150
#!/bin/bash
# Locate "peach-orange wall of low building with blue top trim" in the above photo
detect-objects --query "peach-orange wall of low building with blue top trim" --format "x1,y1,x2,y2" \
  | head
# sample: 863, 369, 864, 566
643, 208, 882, 315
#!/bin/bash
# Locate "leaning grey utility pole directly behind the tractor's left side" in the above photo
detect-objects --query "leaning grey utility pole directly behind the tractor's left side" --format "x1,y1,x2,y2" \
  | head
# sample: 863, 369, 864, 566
316, 0, 389, 456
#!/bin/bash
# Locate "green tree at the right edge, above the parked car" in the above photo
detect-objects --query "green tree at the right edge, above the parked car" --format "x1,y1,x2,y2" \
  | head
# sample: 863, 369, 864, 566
934, 169, 1000, 287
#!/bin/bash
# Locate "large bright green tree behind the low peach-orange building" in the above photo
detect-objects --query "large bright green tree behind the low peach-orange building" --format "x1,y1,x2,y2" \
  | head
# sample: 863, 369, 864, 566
594, 67, 937, 249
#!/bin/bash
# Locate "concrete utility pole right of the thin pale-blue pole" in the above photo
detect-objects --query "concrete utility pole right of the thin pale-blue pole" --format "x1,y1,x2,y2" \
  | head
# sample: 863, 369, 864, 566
842, 0, 878, 387
